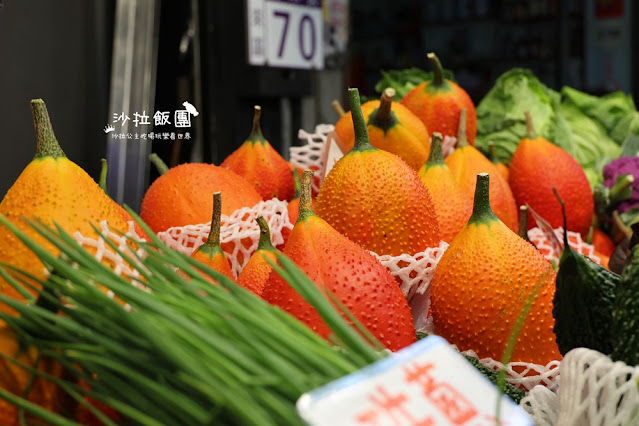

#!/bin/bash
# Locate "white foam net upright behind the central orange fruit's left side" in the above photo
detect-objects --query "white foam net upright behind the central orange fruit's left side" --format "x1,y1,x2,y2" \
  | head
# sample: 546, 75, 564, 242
289, 124, 335, 193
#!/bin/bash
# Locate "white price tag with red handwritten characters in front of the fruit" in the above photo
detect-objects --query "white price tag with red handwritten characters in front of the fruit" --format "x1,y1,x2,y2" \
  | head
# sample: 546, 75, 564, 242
297, 336, 534, 426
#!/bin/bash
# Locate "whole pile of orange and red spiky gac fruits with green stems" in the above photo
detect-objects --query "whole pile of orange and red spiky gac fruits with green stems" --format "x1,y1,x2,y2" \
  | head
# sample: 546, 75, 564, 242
0, 54, 635, 419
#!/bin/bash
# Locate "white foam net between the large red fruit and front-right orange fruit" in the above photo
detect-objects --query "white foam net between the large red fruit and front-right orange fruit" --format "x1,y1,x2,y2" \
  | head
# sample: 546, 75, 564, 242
370, 241, 448, 333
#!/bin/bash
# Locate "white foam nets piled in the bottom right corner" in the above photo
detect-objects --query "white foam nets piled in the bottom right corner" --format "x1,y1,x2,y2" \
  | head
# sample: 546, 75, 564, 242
520, 348, 639, 426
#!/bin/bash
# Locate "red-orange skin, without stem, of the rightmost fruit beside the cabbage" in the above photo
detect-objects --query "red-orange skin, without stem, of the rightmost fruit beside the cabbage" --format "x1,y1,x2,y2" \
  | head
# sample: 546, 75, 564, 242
508, 136, 594, 236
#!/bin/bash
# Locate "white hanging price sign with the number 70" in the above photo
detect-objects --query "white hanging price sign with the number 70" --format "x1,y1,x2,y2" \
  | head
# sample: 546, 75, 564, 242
246, 0, 324, 69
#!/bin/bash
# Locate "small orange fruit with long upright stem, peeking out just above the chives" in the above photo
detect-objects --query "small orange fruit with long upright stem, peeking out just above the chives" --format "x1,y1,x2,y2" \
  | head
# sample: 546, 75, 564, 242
191, 191, 235, 283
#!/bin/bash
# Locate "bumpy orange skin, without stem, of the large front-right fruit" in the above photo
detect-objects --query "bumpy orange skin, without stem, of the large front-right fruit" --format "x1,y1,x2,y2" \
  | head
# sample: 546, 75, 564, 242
430, 212, 561, 365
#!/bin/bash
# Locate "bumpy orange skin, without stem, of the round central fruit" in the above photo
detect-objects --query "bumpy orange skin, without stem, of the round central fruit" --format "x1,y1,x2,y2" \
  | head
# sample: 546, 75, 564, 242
315, 148, 440, 256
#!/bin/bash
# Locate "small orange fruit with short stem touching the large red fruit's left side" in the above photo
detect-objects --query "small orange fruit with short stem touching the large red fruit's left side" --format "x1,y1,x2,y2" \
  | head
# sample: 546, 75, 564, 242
237, 216, 279, 296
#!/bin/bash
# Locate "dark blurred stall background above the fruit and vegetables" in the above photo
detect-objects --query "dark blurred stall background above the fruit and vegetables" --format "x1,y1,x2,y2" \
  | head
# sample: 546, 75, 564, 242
0, 0, 639, 208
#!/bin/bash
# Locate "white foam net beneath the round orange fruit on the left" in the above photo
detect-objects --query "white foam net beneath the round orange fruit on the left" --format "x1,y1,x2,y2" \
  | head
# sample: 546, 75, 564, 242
158, 198, 293, 277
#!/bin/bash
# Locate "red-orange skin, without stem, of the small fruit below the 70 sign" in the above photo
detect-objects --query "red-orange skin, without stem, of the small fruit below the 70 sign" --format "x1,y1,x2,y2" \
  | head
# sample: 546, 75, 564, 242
220, 140, 295, 201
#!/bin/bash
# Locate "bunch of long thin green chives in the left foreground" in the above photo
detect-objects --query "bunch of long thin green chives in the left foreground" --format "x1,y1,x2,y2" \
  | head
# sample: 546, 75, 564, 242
0, 210, 385, 425
